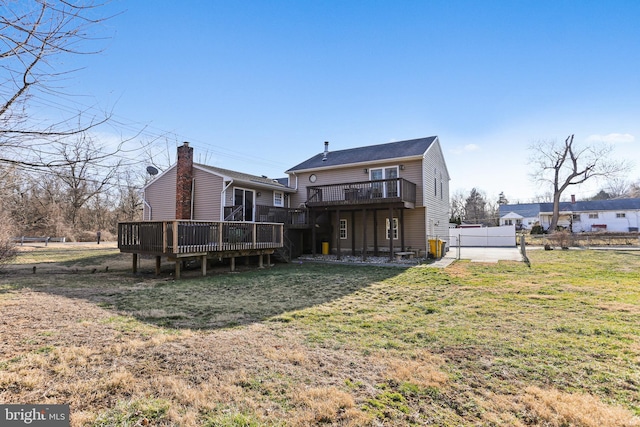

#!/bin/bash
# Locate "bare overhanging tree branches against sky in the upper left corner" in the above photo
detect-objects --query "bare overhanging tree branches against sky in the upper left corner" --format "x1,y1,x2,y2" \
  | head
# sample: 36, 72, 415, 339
0, 0, 110, 168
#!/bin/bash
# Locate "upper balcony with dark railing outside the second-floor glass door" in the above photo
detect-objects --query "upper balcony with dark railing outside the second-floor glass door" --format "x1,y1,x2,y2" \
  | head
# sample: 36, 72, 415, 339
307, 178, 416, 209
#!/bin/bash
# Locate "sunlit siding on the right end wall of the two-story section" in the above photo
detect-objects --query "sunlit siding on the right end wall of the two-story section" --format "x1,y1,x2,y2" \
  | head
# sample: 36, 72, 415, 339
422, 140, 449, 246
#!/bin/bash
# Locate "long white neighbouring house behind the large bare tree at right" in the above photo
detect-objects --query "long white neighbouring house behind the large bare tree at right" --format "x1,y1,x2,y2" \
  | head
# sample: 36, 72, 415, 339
500, 199, 640, 232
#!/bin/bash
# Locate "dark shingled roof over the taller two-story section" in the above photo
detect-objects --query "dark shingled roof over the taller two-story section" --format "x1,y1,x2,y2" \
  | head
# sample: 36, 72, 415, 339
286, 136, 438, 173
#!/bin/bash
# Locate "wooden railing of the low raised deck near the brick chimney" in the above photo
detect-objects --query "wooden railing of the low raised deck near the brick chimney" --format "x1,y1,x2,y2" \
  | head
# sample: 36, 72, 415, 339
118, 220, 284, 254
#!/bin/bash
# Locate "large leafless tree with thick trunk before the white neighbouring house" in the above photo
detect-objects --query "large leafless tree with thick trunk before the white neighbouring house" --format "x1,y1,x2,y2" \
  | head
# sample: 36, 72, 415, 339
529, 135, 629, 232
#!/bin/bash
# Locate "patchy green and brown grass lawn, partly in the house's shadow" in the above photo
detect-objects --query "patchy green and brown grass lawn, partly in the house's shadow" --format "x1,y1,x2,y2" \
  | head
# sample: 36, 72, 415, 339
0, 247, 640, 427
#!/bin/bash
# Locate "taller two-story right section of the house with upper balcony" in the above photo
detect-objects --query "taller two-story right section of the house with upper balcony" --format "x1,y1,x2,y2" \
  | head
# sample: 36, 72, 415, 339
286, 136, 450, 256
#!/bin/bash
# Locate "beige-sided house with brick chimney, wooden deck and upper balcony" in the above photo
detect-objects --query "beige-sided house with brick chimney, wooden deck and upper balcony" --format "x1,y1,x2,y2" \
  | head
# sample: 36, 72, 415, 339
118, 136, 449, 275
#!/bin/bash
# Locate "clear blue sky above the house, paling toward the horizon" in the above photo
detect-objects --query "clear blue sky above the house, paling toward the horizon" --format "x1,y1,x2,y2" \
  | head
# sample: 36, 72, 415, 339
53, 0, 640, 202
